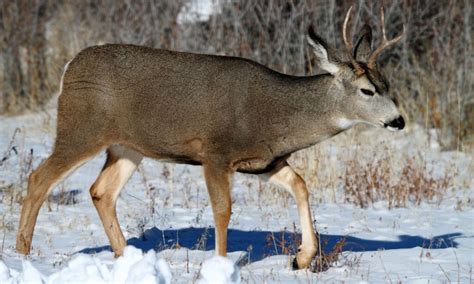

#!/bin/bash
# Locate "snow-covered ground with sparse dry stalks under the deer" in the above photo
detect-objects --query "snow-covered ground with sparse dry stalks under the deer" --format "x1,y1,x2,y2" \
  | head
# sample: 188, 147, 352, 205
0, 111, 474, 283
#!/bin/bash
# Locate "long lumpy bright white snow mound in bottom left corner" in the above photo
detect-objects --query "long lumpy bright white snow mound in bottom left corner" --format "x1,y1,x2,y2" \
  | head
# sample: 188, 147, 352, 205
0, 246, 171, 284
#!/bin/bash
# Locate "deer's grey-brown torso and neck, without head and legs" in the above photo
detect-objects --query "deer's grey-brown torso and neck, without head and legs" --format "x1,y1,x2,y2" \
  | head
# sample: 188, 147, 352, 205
57, 45, 342, 173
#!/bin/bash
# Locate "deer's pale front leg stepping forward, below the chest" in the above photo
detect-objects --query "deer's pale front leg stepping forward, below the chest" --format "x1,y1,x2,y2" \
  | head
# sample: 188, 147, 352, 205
266, 162, 318, 269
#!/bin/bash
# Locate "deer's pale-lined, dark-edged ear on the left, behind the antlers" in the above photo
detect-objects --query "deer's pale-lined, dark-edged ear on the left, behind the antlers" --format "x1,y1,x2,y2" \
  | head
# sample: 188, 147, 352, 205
306, 26, 340, 75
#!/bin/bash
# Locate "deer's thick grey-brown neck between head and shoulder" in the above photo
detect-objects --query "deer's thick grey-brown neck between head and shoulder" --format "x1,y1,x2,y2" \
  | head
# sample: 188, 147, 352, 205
260, 74, 349, 154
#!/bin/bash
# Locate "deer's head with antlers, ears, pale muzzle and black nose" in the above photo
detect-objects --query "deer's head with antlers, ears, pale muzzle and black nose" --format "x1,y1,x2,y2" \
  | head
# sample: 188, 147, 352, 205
307, 7, 405, 130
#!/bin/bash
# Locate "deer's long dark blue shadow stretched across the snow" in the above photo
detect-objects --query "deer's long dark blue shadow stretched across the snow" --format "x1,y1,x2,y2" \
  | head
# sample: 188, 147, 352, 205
80, 227, 462, 262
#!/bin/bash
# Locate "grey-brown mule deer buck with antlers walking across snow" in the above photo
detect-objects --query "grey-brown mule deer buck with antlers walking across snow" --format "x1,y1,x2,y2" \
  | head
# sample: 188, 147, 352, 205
16, 6, 404, 268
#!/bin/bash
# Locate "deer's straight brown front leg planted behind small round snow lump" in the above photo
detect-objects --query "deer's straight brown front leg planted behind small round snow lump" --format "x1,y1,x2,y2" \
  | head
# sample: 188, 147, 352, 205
204, 165, 233, 256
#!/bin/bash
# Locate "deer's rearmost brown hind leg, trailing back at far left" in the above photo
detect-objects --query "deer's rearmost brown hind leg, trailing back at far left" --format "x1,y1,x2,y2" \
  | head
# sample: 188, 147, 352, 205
16, 144, 102, 254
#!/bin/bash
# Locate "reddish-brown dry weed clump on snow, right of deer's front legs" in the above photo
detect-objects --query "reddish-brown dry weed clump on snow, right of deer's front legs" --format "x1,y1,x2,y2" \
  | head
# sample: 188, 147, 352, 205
344, 151, 457, 209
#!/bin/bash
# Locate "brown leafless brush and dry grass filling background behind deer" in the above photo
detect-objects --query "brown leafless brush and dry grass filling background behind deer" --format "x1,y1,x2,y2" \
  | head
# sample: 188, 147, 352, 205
0, 0, 474, 150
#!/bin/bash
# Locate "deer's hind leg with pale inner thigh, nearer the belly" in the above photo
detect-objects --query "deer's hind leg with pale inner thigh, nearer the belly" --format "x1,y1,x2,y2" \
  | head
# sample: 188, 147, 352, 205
90, 146, 143, 256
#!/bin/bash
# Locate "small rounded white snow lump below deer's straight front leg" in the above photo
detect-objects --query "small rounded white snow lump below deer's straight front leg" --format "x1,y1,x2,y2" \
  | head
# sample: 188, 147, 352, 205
199, 256, 240, 284
